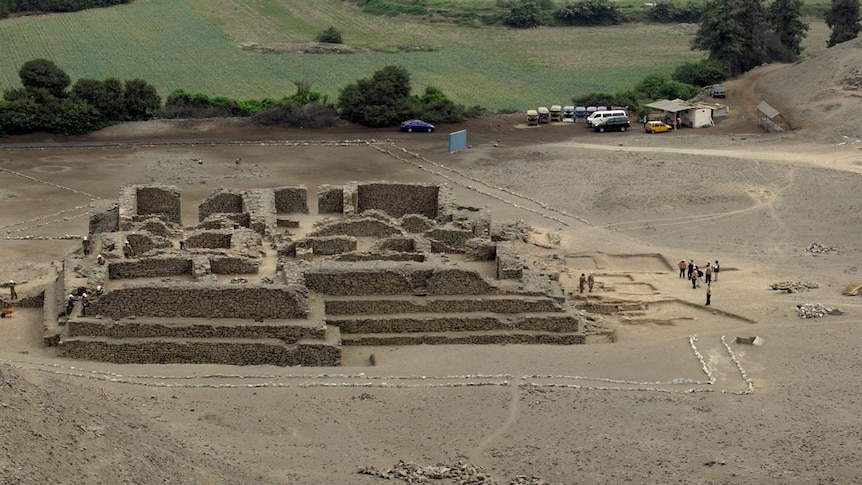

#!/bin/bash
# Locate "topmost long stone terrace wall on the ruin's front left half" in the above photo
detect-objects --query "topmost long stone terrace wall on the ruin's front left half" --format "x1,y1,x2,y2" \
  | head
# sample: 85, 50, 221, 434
90, 283, 308, 320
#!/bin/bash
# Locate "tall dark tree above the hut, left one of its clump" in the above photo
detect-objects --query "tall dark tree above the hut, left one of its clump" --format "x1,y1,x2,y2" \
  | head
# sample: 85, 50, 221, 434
692, 0, 769, 76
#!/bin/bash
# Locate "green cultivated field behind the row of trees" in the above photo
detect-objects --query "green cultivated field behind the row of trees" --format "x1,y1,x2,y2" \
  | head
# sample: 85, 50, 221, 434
0, 0, 828, 111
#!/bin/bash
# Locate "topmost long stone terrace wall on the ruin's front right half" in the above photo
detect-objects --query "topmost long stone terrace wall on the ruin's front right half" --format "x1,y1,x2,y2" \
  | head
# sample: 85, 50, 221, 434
303, 262, 498, 296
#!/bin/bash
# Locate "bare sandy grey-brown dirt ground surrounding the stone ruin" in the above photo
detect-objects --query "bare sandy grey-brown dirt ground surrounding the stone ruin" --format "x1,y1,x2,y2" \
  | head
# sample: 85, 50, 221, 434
0, 57, 862, 485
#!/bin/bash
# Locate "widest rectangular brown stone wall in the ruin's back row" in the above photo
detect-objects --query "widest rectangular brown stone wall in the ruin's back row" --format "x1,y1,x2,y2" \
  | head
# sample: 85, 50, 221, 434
356, 182, 440, 219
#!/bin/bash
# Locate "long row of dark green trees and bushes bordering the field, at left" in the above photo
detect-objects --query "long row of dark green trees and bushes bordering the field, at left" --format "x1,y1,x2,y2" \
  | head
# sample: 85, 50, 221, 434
0, 59, 482, 135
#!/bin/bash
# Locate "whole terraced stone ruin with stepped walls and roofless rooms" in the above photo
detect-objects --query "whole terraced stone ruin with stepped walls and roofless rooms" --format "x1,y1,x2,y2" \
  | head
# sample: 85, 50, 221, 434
44, 182, 585, 366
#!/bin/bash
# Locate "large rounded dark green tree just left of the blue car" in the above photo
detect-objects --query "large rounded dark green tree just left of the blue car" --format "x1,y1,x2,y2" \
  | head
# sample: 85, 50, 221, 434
338, 66, 415, 128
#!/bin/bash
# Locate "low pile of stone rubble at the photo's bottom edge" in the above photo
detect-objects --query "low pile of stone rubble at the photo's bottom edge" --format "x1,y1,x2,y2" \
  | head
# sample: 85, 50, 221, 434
358, 461, 548, 485
